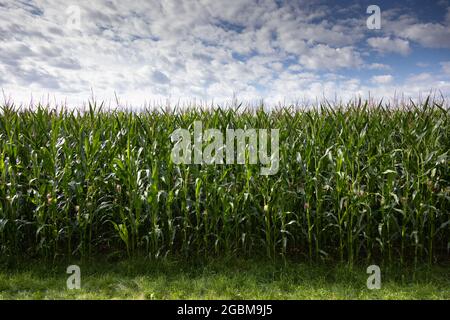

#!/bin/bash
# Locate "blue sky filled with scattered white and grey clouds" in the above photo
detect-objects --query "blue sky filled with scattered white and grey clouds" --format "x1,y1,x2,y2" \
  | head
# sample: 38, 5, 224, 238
0, 0, 450, 107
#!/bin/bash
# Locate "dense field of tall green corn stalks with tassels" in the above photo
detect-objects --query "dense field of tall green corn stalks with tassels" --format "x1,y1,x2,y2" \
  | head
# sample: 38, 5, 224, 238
0, 100, 450, 264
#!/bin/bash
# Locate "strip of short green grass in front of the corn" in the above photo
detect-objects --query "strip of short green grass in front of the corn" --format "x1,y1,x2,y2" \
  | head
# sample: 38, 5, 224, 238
0, 259, 450, 299
